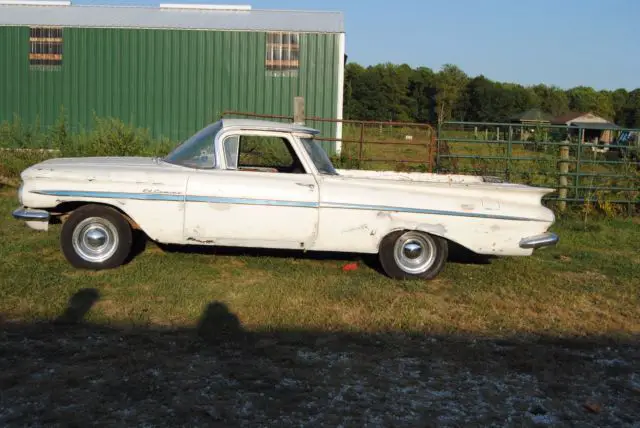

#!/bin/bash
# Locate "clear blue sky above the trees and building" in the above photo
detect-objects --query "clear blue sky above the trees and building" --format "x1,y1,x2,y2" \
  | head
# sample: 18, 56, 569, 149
73, 0, 640, 90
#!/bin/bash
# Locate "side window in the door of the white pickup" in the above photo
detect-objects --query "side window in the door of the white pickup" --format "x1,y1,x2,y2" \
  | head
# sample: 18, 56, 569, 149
223, 135, 305, 174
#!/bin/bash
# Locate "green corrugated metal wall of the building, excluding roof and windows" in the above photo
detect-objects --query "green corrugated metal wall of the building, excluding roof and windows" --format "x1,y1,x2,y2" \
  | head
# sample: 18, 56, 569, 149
0, 27, 340, 150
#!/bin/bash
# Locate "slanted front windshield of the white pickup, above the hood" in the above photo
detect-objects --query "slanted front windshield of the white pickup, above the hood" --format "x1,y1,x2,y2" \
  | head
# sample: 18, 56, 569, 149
164, 122, 222, 168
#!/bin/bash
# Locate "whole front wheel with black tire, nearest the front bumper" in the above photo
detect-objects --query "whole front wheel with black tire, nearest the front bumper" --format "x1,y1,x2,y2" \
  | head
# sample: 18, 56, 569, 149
60, 205, 133, 270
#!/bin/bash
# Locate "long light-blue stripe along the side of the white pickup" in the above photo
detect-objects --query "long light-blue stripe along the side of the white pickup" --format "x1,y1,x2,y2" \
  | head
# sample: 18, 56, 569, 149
33, 190, 546, 222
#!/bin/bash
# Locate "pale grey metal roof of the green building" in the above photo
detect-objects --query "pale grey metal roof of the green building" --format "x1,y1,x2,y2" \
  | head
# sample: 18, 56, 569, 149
0, 5, 344, 33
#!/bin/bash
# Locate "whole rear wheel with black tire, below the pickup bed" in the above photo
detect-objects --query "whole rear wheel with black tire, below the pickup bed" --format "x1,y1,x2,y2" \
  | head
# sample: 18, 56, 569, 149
379, 230, 449, 279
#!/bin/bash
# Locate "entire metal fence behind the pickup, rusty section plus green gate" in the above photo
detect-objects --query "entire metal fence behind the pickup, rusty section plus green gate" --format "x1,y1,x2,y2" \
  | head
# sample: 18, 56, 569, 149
223, 111, 640, 213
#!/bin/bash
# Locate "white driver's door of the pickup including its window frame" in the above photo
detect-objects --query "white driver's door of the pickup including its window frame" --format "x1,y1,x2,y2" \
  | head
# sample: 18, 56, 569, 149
185, 131, 319, 248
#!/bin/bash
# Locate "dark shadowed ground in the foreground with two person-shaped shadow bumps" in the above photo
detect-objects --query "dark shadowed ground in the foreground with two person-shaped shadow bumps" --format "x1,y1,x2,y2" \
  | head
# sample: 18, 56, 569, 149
0, 290, 640, 426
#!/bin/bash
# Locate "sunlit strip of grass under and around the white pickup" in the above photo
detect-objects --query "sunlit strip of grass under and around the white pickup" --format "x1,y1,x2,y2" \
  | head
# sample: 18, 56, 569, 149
0, 187, 640, 337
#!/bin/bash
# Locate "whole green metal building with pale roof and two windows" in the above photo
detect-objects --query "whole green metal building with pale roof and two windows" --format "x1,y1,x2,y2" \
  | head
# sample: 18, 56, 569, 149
0, 1, 345, 152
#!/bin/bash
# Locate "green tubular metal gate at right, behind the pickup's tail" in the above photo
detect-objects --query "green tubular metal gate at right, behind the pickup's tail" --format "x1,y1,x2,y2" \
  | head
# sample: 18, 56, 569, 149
436, 122, 640, 213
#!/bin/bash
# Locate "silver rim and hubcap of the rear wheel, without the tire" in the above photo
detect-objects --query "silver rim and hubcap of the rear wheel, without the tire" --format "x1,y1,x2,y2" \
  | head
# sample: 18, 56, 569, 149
393, 232, 436, 274
